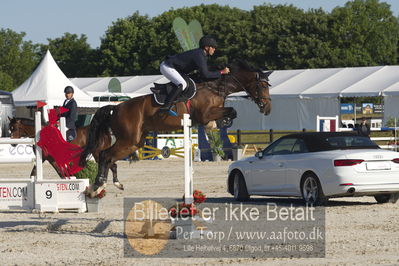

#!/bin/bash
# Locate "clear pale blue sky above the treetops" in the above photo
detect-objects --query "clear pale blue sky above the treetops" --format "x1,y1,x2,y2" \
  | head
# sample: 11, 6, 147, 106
0, 0, 399, 48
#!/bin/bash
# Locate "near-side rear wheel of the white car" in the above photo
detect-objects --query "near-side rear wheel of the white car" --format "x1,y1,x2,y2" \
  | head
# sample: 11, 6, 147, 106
301, 174, 327, 205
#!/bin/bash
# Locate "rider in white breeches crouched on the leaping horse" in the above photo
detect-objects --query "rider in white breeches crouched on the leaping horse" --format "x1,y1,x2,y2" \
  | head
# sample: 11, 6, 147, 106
160, 36, 230, 111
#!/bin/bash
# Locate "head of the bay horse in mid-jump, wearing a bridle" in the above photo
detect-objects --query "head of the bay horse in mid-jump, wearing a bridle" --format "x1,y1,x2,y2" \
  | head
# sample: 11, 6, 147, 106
231, 61, 273, 115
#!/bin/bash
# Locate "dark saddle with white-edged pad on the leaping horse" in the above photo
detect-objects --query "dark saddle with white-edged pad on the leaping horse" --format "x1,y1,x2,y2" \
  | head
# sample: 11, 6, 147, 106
151, 75, 197, 105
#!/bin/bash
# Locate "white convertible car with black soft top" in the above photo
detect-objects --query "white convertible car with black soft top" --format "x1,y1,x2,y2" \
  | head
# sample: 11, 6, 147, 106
227, 132, 399, 204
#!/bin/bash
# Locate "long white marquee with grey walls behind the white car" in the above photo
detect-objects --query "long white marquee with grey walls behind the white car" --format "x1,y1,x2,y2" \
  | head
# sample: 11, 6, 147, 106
226, 66, 399, 130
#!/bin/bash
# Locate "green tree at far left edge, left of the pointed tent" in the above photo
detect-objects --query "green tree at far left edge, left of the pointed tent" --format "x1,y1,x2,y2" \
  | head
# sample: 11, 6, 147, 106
0, 29, 39, 91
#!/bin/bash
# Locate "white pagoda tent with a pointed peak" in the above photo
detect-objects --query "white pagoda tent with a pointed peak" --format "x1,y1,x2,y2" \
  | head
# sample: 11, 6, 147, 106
12, 51, 98, 107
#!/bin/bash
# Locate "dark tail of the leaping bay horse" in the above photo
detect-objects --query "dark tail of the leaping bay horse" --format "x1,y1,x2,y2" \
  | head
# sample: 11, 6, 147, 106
79, 105, 115, 166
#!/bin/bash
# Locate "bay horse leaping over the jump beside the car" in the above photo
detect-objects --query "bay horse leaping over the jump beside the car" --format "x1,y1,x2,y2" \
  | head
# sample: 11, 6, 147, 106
80, 61, 272, 197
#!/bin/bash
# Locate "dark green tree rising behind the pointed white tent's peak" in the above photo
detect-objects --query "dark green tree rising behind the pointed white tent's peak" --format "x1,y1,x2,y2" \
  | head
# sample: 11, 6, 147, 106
40, 32, 99, 77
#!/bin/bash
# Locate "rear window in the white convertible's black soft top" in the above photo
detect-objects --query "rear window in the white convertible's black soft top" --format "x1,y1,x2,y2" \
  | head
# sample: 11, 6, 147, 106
326, 136, 378, 149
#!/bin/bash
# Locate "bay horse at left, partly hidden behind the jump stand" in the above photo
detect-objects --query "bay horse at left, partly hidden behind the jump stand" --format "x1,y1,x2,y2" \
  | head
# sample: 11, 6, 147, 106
8, 117, 123, 190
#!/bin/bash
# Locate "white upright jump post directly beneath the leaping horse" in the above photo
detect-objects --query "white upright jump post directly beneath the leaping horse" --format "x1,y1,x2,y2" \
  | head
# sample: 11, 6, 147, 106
182, 114, 193, 204
